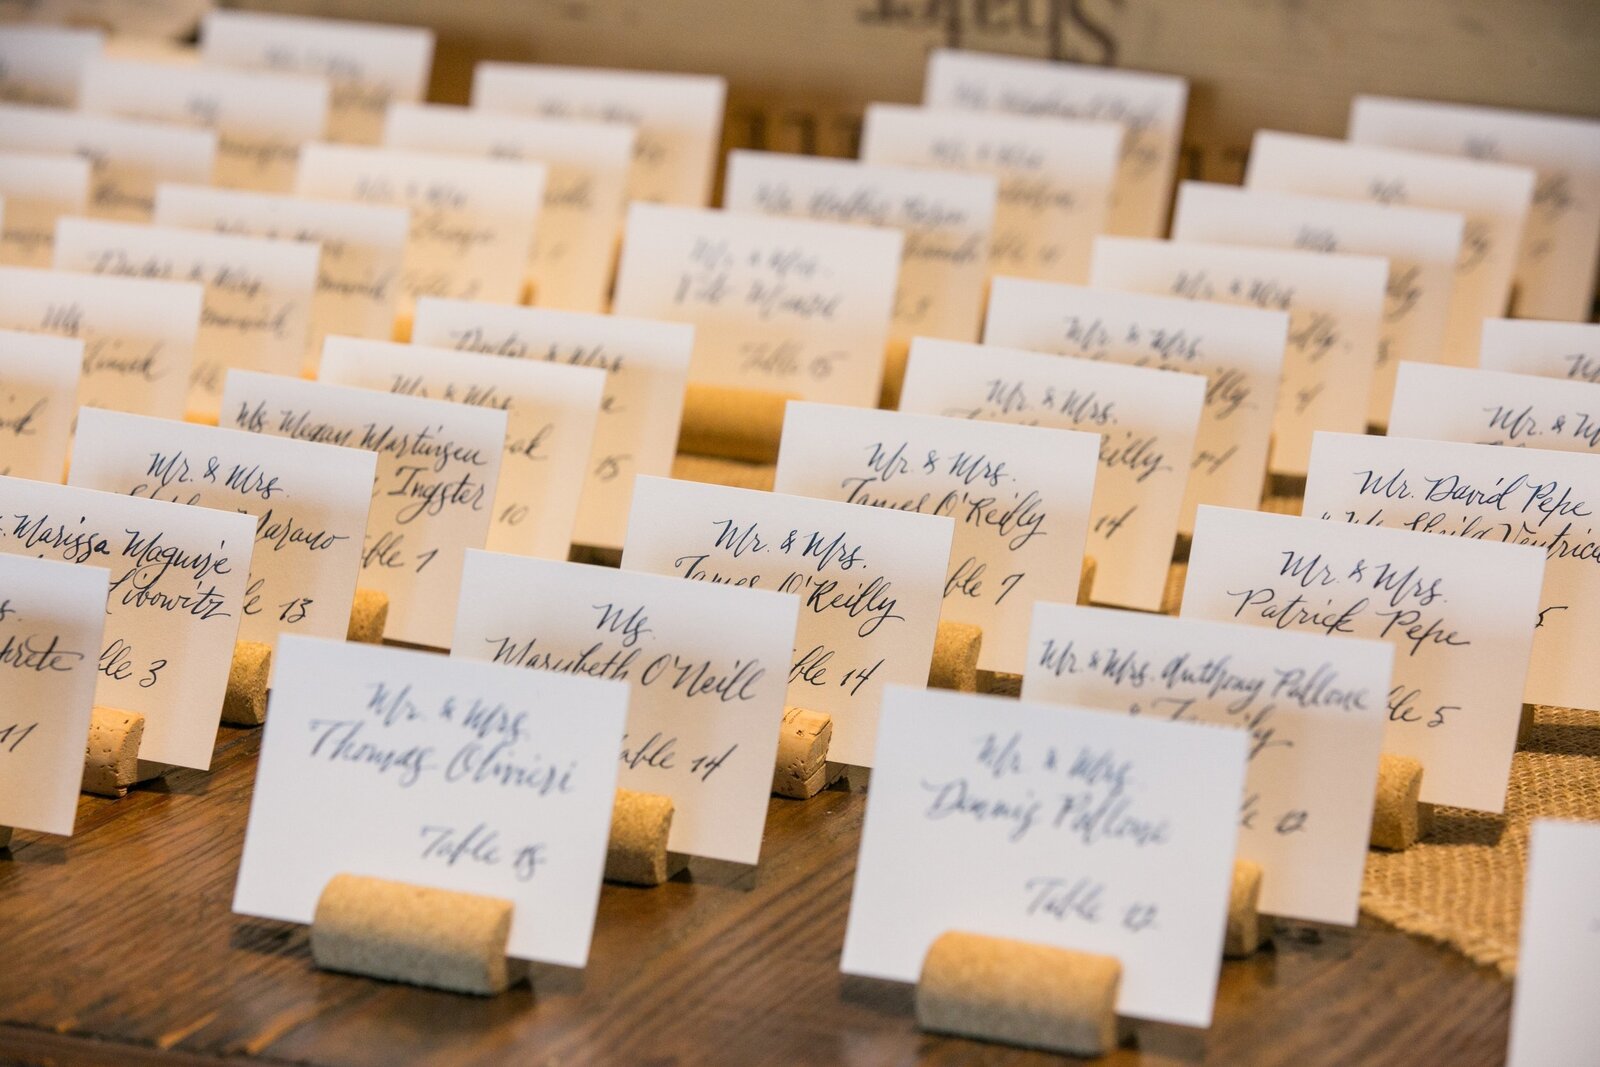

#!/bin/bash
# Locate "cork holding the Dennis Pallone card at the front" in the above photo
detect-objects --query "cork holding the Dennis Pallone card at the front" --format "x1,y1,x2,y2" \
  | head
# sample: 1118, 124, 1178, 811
917, 933, 1122, 1056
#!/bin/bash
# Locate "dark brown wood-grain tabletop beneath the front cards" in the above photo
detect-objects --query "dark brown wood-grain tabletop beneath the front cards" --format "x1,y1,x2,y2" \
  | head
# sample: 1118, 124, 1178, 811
0, 728, 1510, 1067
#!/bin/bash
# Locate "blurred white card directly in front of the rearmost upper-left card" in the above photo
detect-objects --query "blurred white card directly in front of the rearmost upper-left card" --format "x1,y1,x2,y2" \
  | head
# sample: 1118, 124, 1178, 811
78, 59, 328, 192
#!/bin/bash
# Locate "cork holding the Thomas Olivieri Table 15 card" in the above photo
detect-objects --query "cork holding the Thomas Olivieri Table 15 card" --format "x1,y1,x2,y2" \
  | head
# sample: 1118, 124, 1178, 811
310, 875, 526, 997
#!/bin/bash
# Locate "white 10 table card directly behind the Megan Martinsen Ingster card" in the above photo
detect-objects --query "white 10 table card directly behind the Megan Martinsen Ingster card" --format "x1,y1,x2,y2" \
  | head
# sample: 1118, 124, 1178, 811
317, 338, 605, 560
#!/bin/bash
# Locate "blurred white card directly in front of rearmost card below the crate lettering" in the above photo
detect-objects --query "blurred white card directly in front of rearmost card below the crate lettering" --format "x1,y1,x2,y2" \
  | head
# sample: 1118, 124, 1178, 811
861, 104, 1123, 282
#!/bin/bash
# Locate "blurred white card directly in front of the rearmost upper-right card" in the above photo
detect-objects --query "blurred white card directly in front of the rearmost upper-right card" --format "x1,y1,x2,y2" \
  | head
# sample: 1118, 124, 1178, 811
1245, 130, 1534, 365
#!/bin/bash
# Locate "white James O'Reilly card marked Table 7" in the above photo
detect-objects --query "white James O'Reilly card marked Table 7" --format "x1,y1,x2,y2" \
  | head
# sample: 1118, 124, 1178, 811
773, 404, 1101, 673
